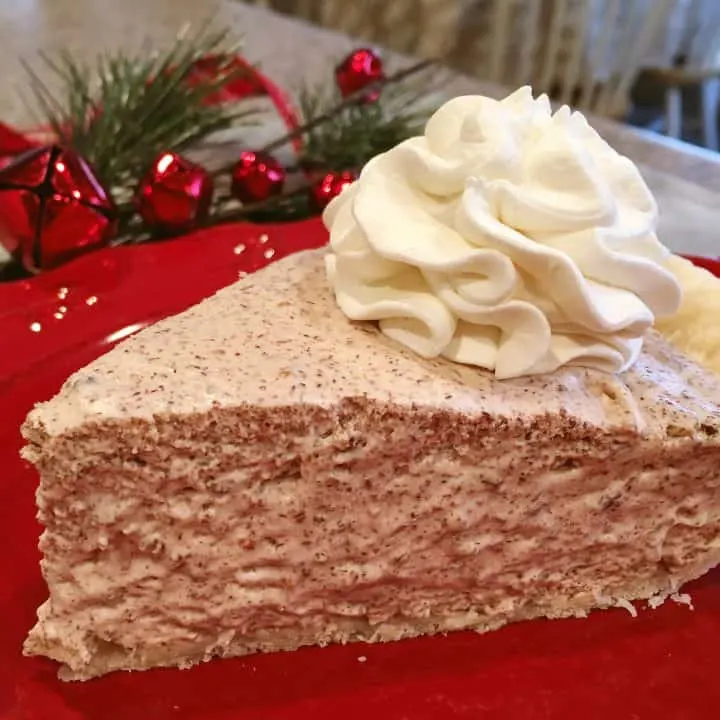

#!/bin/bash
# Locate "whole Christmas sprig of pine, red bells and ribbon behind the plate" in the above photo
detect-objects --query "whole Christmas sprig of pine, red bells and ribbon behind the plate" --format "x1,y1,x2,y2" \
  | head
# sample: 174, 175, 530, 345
0, 19, 433, 280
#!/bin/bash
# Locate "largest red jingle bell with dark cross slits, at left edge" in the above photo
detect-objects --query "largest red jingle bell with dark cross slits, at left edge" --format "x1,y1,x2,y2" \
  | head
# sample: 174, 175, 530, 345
0, 145, 117, 272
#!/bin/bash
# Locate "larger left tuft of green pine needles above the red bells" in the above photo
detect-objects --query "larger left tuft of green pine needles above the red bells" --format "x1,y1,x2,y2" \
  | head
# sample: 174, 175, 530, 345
26, 28, 255, 188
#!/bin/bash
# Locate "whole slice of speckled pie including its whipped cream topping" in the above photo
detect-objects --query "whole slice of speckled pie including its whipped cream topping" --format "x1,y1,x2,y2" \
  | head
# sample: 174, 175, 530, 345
24, 90, 720, 679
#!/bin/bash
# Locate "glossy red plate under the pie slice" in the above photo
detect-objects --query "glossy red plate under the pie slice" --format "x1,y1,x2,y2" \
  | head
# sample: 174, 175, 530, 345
0, 220, 720, 720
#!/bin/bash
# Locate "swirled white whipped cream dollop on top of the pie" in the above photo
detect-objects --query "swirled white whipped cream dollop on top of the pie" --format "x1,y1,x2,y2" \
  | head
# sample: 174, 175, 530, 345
323, 87, 682, 378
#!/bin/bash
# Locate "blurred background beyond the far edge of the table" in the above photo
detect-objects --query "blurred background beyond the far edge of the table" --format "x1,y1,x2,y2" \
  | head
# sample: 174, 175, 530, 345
239, 0, 720, 152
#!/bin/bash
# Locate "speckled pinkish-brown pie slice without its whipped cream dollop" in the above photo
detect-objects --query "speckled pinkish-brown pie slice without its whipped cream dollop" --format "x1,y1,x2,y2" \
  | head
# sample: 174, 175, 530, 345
25, 253, 720, 679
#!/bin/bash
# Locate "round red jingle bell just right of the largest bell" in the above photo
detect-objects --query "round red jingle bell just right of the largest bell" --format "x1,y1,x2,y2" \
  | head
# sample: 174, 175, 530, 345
137, 152, 214, 235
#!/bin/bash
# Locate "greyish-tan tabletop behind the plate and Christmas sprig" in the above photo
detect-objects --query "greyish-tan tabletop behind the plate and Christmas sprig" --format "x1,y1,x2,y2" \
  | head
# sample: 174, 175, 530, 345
0, 0, 720, 256
